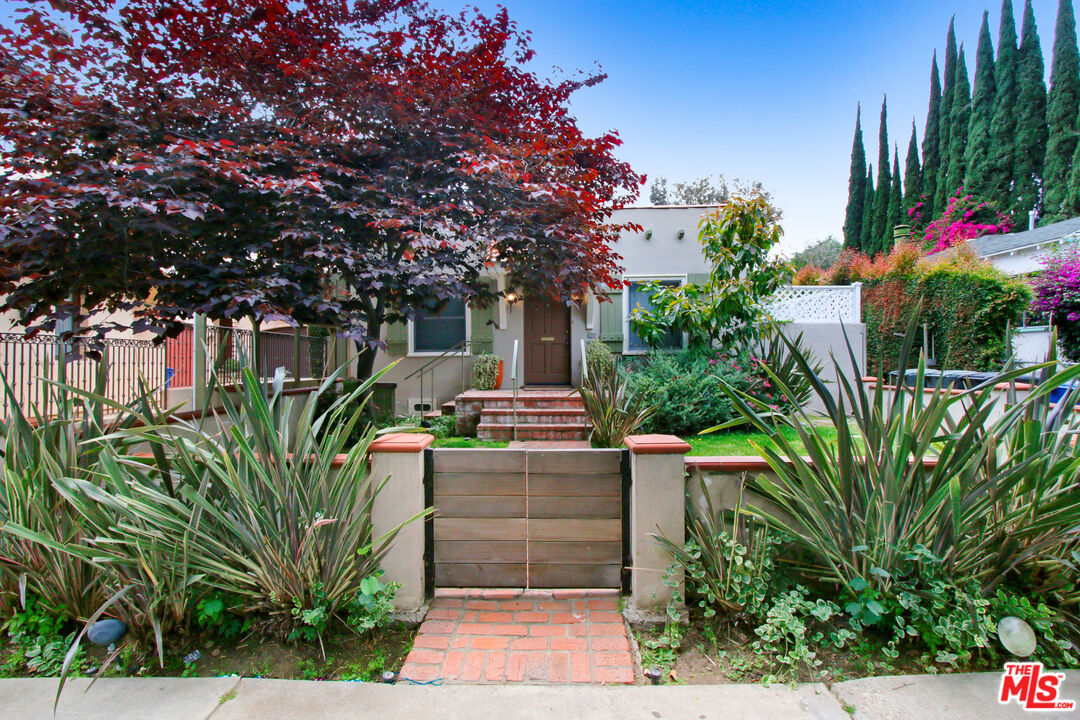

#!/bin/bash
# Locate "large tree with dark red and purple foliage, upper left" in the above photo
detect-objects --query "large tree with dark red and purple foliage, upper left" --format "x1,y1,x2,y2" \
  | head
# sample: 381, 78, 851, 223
0, 0, 642, 377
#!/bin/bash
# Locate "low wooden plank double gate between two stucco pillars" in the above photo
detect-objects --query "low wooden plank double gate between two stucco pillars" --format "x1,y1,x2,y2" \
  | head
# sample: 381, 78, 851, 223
428, 449, 629, 588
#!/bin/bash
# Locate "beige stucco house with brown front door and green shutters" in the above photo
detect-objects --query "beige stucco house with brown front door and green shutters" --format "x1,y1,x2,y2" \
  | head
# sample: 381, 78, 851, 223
376, 205, 864, 413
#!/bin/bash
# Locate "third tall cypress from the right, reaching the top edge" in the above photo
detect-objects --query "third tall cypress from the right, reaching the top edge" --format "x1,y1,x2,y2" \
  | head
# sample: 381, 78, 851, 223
986, 0, 1020, 212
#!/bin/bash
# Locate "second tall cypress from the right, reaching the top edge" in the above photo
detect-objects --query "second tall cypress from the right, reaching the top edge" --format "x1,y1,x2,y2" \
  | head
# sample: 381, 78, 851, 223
1011, 0, 1047, 216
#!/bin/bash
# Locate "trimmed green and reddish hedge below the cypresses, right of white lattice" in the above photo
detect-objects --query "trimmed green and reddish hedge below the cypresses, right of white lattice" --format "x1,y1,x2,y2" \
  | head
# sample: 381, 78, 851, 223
863, 261, 1031, 372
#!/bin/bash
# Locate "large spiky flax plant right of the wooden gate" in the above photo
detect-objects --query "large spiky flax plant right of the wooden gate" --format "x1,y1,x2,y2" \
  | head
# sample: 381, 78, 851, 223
726, 312, 1080, 596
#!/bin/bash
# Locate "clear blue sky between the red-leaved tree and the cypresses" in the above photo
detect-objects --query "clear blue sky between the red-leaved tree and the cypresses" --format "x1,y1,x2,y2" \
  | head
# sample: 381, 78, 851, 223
437, 0, 1057, 252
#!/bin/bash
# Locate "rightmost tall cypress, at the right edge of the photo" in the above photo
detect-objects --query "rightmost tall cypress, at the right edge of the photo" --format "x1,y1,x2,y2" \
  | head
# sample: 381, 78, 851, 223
1042, 0, 1080, 216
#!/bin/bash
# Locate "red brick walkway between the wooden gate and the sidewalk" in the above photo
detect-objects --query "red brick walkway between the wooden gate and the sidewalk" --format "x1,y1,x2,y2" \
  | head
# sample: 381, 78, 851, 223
401, 589, 634, 683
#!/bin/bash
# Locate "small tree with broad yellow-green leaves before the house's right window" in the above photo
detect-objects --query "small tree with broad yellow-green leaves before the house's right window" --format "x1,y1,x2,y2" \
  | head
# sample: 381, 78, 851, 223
630, 195, 792, 351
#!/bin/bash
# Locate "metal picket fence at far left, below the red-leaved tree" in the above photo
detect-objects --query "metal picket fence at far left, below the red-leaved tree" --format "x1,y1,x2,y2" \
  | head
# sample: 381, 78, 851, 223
0, 332, 168, 418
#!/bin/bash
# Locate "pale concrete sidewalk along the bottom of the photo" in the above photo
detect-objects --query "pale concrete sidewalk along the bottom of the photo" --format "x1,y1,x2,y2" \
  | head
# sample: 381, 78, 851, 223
0, 673, 1080, 720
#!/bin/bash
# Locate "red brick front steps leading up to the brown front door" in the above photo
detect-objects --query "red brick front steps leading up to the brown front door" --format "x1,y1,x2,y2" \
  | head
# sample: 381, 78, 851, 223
455, 389, 589, 440
